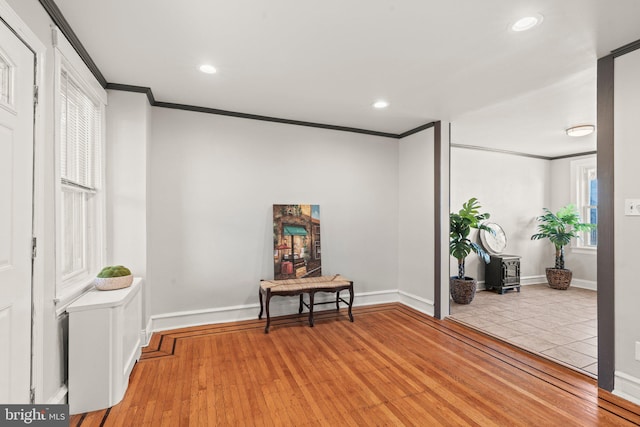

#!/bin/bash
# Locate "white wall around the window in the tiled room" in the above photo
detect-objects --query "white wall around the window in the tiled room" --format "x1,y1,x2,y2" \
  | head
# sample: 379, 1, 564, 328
547, 154, 598, 290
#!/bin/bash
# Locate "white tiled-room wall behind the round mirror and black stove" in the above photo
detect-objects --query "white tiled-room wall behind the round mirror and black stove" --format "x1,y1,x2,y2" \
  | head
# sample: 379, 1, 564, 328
450, 147, 554, 283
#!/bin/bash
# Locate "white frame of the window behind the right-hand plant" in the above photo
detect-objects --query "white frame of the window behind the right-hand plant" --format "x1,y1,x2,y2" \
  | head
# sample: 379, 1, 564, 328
571, 156, 598, 254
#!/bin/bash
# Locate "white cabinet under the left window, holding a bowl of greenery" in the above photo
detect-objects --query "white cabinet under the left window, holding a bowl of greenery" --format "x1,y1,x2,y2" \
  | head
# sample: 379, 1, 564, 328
67, 278, 142, 414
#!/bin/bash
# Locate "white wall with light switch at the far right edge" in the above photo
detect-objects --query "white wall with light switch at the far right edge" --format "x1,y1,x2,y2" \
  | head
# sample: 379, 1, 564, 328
614, 50, 640, 403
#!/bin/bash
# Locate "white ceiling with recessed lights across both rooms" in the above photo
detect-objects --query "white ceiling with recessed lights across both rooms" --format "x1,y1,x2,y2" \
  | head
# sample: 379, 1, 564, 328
55, 0, 640, 157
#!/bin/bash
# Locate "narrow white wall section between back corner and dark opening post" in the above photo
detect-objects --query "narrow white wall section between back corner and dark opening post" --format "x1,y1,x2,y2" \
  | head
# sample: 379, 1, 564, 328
398, 128, 434, 315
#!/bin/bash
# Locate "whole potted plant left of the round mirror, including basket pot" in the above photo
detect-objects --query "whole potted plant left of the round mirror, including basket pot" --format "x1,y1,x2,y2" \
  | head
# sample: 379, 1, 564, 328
449, 197, 494, 304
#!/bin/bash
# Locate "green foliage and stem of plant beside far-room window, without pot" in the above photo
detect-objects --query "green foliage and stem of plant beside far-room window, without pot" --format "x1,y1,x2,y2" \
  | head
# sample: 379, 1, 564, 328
531, 204, 596, 269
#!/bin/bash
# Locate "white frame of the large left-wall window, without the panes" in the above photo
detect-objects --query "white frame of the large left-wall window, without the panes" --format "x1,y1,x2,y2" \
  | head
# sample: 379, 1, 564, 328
52, 28, 107, 312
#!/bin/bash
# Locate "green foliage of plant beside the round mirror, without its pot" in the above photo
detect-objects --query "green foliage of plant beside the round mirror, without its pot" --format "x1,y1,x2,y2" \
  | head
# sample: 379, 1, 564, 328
449, 197, 495, 279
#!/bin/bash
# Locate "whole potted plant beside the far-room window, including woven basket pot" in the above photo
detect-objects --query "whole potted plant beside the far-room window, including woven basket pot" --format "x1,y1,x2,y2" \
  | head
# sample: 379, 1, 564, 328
531, 204, 596, 290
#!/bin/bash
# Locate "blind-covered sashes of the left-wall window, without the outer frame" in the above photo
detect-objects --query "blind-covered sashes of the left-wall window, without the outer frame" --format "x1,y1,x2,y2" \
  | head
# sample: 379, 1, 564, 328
59, 68, 102, 281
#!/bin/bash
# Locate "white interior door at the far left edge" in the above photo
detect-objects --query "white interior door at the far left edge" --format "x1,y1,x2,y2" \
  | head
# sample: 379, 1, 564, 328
0, 17, 35, 403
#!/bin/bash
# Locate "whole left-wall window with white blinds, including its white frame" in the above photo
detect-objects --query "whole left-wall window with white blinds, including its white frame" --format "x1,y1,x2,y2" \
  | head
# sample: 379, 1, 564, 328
51, 28, 107, 304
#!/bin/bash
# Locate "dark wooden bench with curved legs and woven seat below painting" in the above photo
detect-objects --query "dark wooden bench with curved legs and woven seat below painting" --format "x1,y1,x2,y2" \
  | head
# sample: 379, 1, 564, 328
258, 274, 353, 334
